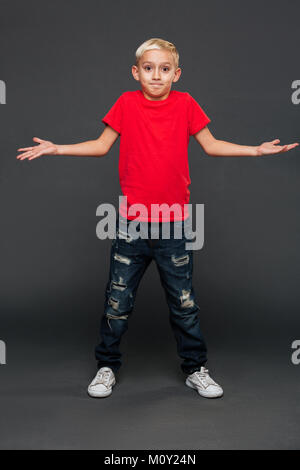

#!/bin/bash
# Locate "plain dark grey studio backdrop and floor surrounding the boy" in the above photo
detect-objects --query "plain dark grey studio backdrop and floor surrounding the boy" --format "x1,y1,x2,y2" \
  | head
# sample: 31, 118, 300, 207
0, 0, 300, 449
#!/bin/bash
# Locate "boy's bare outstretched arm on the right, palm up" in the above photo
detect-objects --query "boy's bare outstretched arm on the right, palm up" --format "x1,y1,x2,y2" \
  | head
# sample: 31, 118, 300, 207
194, 126, 299, 157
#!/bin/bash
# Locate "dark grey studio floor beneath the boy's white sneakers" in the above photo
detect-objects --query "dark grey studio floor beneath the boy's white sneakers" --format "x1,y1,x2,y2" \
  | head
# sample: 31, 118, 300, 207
0, 342, 300, 450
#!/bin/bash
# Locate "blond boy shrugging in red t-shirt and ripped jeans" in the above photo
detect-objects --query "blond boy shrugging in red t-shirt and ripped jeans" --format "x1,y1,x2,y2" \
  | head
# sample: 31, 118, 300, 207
17, 38, 299, 398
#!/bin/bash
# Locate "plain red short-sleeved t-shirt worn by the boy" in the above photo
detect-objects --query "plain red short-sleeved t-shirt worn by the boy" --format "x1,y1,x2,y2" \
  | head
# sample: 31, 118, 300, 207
102, 90, 211, 222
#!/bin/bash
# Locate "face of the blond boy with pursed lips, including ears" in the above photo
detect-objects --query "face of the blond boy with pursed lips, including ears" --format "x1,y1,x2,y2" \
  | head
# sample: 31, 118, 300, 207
132, 49, 181, 100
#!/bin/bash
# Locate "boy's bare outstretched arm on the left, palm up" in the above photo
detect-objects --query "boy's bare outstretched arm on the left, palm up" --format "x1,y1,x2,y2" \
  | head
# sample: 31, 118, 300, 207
17, 126, 119, 160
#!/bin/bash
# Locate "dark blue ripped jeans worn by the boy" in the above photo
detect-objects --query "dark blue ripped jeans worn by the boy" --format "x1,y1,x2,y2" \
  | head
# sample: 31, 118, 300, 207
95, 214, 207, 374
